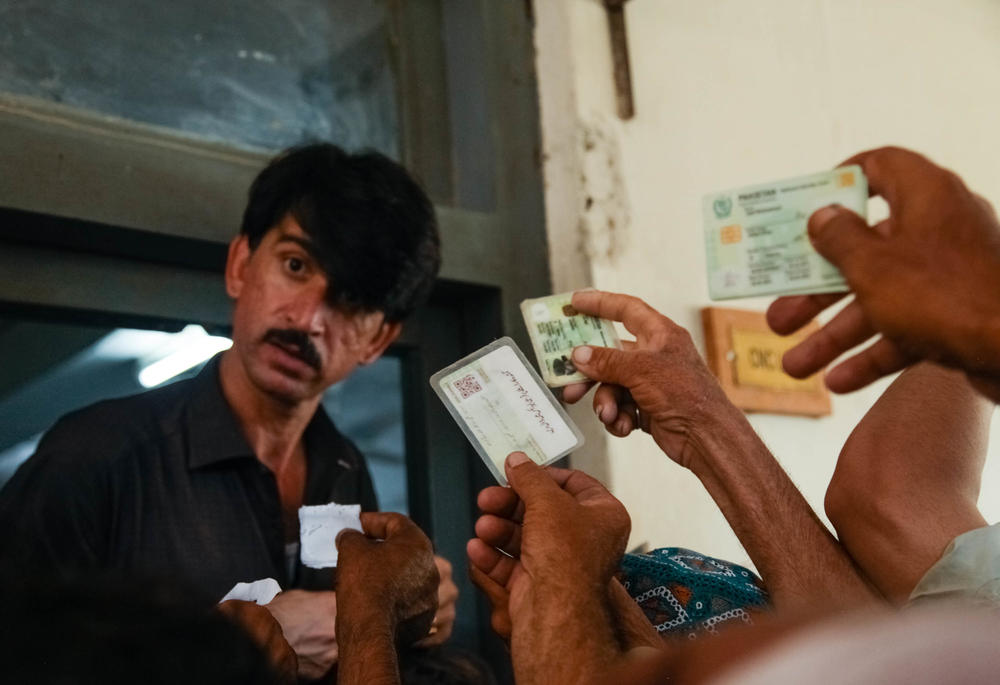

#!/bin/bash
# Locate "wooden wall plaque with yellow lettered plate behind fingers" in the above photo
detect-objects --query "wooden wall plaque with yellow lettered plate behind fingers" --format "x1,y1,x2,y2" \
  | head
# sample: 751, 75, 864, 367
701, 307, 831, 416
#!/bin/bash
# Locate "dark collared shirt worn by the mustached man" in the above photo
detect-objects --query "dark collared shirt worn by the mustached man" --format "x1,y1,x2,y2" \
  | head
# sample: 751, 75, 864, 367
0, 359, 377, 598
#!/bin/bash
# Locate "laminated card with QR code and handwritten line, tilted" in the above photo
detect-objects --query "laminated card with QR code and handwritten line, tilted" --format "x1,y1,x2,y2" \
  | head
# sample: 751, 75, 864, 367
431, 338, 583, 485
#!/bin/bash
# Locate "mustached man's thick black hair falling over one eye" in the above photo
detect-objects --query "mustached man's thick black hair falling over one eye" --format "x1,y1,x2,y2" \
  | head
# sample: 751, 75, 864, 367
240, 143, 441, 321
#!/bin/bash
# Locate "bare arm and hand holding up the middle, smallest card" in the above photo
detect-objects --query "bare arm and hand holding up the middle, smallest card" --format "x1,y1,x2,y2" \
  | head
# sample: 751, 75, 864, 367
564, 291, 877, 609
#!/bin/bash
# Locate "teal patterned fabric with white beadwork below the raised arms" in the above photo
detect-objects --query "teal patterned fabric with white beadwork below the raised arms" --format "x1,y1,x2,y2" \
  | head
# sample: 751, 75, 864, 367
618, 547, 769, 639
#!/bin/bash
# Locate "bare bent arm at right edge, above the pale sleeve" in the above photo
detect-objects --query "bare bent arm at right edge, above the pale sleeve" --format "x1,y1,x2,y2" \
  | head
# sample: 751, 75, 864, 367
826, 364, 993, 603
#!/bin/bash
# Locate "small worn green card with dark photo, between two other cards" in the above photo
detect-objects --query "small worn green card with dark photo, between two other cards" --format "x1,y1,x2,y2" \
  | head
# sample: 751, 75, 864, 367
521, 293, 622, 388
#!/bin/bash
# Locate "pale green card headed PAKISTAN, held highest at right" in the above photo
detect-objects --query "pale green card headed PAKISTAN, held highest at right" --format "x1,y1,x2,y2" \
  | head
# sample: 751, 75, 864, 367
702, 165, 868, 300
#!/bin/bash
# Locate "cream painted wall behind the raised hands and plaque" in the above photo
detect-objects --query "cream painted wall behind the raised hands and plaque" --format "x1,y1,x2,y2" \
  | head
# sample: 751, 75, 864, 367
534, 0, 1000, 563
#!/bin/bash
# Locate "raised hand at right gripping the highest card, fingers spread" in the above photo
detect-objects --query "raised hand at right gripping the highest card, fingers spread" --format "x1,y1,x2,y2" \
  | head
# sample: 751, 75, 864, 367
768, 148, 1000, 400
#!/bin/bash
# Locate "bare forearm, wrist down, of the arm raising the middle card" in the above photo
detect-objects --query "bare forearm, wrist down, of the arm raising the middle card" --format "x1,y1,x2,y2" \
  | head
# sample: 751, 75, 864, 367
691, 408, 876, 609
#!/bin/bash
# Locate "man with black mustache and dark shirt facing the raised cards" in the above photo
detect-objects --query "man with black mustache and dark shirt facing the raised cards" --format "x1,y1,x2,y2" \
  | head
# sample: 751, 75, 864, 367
0, 144, 457, 678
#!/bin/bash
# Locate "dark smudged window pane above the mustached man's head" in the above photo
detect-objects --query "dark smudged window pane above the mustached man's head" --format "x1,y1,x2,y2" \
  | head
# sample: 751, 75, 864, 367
0, 0, 399, 158
